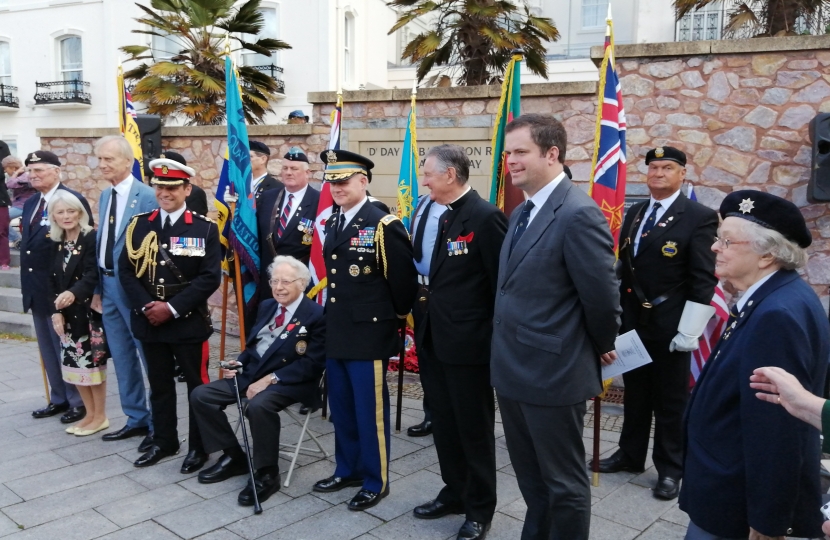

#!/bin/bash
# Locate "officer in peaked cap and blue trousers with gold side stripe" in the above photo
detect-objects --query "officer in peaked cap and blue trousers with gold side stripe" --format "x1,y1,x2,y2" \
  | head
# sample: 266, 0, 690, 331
314, 150, 417, 510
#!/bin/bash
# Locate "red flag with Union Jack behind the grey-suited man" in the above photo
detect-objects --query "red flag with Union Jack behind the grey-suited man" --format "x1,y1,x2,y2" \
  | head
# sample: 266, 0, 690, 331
589, 14, 626, 251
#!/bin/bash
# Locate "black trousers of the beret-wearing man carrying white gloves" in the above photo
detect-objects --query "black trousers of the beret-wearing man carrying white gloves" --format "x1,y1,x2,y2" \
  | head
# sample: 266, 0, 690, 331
620, 340, 691, 480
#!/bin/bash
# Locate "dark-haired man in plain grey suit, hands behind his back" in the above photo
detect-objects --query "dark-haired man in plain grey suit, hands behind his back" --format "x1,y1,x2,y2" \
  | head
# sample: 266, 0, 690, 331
490, 114, 620, 540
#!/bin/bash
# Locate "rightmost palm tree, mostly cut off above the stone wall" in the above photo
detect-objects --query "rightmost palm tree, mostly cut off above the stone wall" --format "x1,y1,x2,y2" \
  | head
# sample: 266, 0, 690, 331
674, 0, 830, 37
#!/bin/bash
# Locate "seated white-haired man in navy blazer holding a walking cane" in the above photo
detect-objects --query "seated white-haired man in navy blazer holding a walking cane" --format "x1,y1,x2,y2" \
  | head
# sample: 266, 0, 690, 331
190, 256, 326, 506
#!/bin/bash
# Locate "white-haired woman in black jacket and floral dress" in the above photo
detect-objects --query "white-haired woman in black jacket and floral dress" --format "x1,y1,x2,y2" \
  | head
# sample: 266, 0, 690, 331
47, 190, 109, 437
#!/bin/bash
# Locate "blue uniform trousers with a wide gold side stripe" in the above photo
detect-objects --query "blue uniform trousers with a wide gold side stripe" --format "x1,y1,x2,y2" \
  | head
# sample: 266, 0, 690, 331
326, 358, 390, 493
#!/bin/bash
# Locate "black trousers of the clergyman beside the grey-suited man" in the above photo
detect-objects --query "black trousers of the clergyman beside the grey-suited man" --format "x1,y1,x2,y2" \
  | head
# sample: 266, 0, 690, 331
418, 336, 496, 523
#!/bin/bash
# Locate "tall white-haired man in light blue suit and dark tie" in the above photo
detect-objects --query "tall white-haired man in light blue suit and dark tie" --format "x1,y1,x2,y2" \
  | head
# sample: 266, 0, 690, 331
92, 135, 156, 450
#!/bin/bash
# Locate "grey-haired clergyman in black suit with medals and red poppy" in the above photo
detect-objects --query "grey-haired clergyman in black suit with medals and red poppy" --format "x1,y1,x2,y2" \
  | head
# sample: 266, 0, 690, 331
413, 144, 507, 540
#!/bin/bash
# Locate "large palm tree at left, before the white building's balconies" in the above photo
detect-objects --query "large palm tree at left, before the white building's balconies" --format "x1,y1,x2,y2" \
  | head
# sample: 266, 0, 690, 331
121, 0, 291, 125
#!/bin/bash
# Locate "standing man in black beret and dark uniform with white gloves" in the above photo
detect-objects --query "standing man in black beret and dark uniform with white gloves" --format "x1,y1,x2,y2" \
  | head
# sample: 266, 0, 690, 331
600, 146, 718, 500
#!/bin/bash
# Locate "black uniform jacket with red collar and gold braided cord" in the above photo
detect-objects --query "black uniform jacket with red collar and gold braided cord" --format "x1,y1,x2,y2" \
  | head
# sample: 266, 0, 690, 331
118, 209, 222, 343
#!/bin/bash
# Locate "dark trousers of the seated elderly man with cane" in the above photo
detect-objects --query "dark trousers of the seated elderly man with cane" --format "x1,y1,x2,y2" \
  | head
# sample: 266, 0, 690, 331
190, 379, 296, 469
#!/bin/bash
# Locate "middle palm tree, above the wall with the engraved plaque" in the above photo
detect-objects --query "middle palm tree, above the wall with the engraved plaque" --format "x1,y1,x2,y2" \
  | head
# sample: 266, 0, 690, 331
387, 0, 559, 86
